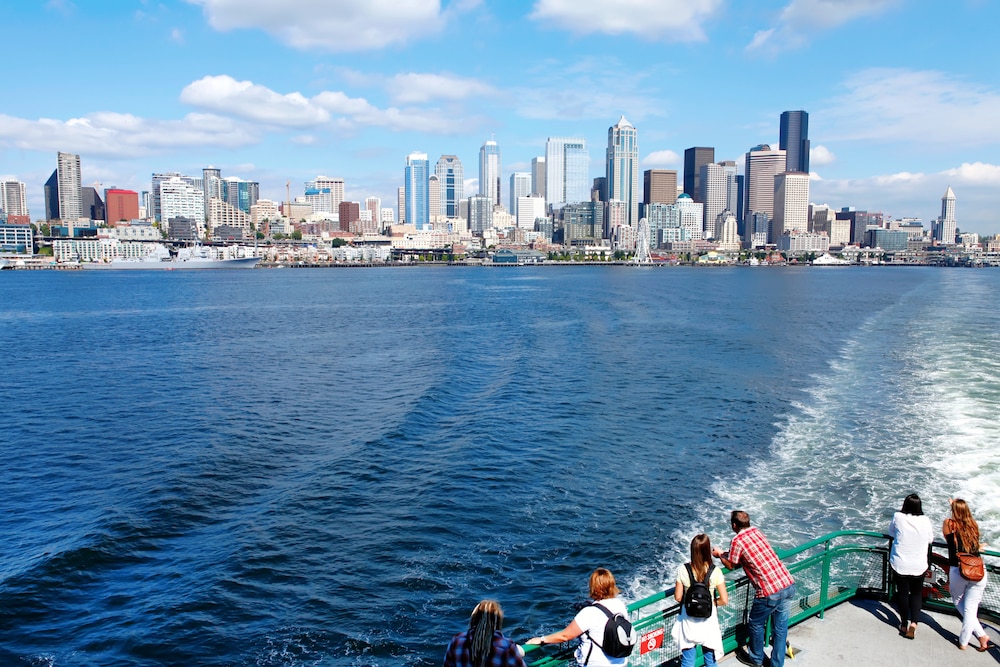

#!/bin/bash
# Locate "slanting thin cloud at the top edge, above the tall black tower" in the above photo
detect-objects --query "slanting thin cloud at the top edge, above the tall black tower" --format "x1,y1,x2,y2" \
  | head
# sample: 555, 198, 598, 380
746, 0, 901, 55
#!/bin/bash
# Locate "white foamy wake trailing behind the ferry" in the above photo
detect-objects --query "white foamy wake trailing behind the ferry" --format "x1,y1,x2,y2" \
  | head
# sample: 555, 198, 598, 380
630, 272, 1000, 597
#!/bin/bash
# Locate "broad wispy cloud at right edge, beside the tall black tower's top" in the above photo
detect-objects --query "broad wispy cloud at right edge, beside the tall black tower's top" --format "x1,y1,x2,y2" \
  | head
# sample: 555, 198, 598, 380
824, 68, 1000, 146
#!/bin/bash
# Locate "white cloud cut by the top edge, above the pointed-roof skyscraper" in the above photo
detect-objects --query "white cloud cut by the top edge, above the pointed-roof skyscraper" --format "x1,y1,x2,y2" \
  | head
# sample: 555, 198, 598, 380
529, 0, 722, 42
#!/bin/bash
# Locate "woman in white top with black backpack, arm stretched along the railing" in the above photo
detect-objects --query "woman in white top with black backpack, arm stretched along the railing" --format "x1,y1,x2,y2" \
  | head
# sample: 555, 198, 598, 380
527, 567, 628, 667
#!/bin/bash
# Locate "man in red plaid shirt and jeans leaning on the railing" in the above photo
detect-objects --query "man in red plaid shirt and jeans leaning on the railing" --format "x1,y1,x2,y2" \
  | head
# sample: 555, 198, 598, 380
712, 510, 795, 667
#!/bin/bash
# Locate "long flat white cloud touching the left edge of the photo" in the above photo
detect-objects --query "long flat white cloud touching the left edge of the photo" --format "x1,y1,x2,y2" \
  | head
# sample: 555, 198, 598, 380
0, 112, 258, 158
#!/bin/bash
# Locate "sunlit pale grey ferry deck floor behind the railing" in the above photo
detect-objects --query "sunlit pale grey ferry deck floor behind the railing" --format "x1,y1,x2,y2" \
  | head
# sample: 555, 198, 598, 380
724, 600, 1000, 667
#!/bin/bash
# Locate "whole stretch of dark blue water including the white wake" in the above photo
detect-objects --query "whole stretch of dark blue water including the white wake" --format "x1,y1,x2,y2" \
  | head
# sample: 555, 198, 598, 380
0, 267, 1000, 667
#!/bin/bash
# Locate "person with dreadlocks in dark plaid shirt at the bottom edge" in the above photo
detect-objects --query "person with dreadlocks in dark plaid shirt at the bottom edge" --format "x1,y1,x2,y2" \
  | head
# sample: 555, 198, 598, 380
444, 600, 525, 667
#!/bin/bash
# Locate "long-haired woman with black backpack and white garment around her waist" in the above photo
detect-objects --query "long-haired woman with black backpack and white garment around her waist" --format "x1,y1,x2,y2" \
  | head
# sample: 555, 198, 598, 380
673, 533, 729, 667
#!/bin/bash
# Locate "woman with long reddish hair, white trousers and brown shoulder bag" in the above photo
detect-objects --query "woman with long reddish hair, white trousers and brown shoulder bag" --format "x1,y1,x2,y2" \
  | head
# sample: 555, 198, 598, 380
941, 498, 990, 652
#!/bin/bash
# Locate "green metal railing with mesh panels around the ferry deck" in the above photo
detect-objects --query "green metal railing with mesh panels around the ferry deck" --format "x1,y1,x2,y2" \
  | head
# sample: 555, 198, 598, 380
524, 531, 1000, 667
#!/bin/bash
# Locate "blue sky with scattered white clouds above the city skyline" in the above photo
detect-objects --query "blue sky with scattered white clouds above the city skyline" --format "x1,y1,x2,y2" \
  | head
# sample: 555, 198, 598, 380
0, 0, 1000, 234
